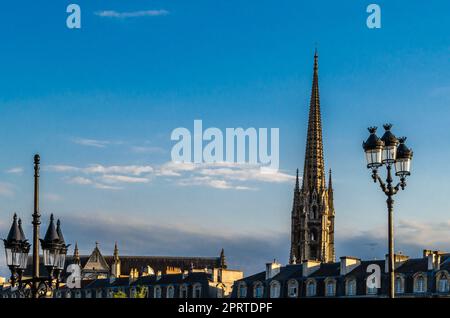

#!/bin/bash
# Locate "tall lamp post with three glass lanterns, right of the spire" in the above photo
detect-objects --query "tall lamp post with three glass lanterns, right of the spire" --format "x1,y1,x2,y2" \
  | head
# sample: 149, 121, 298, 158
363, 124, 413, 298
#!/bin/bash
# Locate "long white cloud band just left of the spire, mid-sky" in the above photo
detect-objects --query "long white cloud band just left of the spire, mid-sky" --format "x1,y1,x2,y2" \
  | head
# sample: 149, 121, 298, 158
46, 161, 295, 190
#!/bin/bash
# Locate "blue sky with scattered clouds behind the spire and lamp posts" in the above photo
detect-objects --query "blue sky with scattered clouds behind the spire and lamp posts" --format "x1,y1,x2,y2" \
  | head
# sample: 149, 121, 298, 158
0, 0, 450, 272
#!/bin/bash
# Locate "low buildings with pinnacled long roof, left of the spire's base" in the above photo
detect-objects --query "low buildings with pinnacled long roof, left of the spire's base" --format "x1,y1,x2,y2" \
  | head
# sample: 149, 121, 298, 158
0, 243, 244, 298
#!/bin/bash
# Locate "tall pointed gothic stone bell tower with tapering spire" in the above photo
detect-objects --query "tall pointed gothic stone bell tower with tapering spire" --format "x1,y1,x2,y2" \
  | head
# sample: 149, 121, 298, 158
290, 51, 335, 263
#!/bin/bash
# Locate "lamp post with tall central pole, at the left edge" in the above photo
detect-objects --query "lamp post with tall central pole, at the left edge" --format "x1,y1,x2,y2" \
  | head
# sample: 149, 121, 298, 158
3, 155, 69, 298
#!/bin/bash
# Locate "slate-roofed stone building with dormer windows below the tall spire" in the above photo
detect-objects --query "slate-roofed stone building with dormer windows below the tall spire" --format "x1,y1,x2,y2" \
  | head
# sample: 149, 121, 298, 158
232, 250, 450, 298
